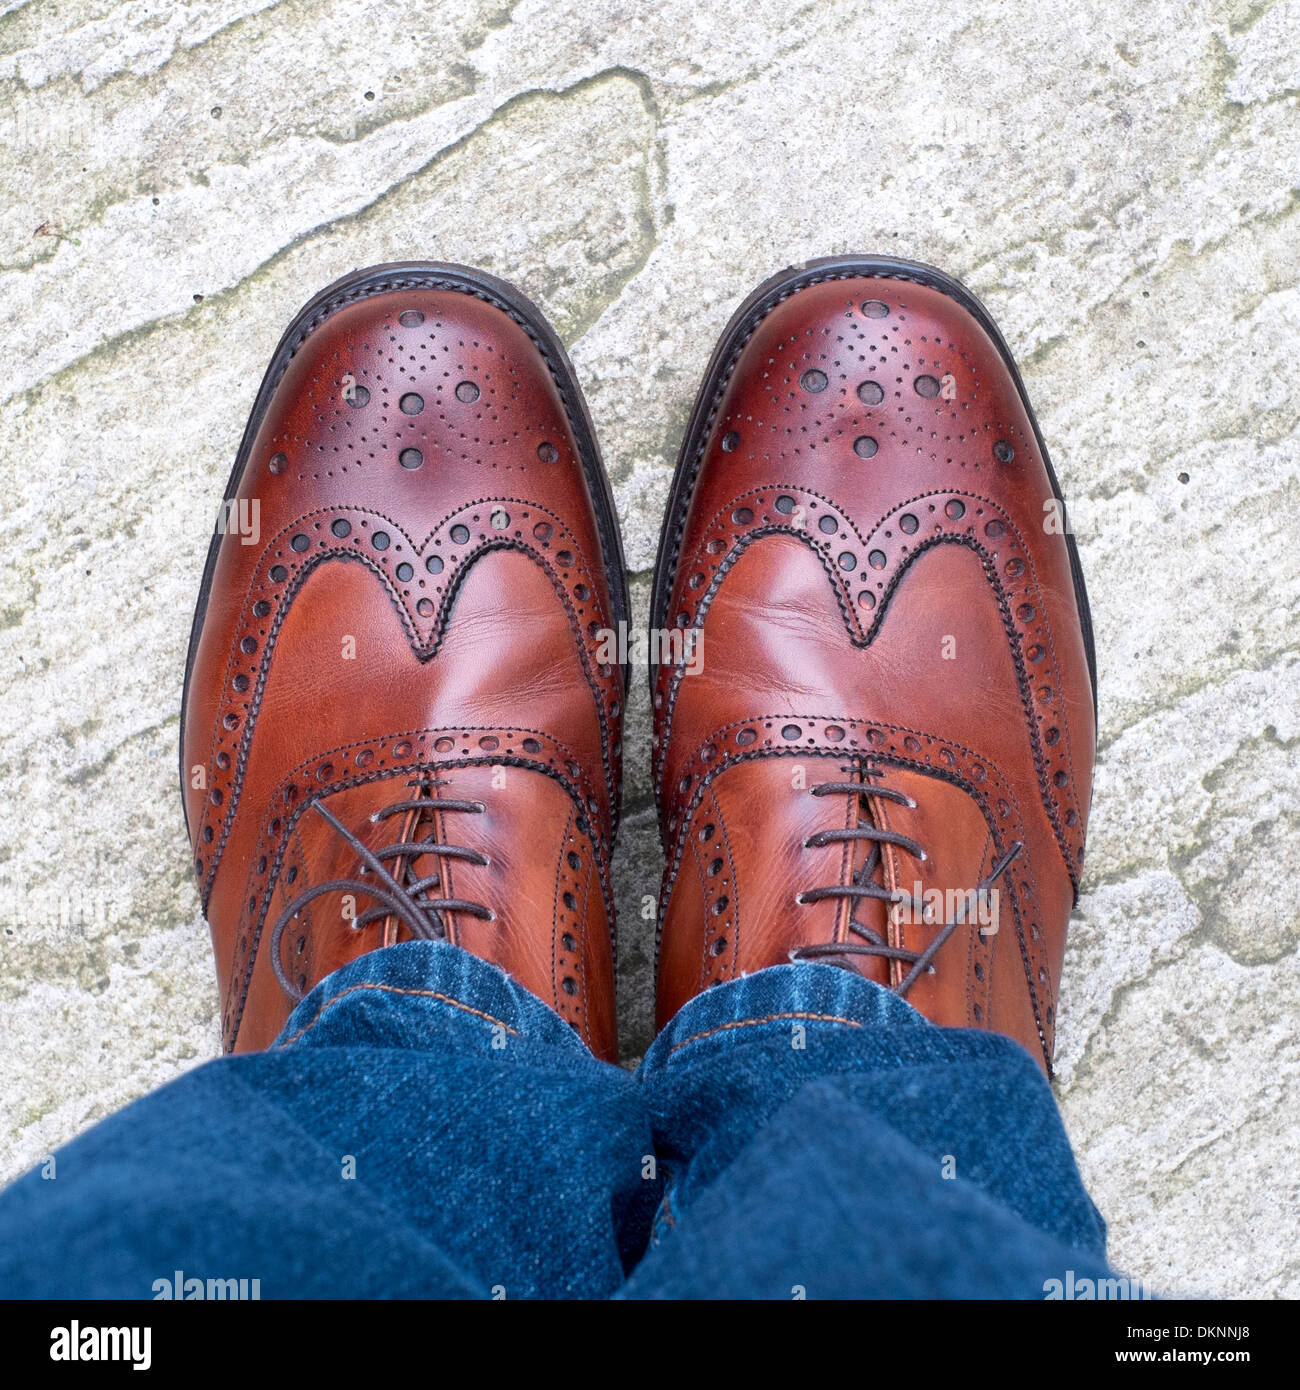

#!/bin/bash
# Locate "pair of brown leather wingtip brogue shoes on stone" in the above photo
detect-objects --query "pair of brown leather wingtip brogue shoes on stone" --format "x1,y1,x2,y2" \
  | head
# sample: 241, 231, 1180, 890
181, 257, 1096, 1070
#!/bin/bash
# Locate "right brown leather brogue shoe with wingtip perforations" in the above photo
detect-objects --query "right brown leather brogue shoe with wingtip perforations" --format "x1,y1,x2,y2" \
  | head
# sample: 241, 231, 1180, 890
651, 257, 1096, 1072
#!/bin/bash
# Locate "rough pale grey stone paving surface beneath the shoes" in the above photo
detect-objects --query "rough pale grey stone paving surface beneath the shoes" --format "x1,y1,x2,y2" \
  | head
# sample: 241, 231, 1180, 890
0, 0, 1300, 1297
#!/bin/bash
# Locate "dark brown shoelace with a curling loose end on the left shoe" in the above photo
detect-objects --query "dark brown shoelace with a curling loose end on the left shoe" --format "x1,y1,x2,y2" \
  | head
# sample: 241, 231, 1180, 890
271, 780, 496, 1002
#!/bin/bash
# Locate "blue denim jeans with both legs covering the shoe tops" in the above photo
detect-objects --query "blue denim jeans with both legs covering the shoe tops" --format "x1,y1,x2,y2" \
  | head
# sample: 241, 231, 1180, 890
0, 941, 1110, 1298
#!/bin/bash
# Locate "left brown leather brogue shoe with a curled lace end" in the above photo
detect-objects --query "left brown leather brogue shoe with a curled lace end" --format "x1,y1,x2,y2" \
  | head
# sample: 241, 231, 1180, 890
181, 264, 627, 1058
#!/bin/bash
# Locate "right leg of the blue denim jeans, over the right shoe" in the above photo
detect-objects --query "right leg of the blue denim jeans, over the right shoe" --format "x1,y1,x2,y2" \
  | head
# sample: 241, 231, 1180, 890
623, 965, 1108, 1298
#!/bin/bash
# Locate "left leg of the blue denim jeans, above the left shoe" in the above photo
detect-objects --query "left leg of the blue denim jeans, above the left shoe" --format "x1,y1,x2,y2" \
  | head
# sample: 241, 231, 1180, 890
0, 941, 656, 1298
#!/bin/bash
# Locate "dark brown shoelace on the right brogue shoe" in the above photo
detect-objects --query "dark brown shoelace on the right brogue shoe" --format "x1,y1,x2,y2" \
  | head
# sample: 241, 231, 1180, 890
790, 766, 1025, 997
